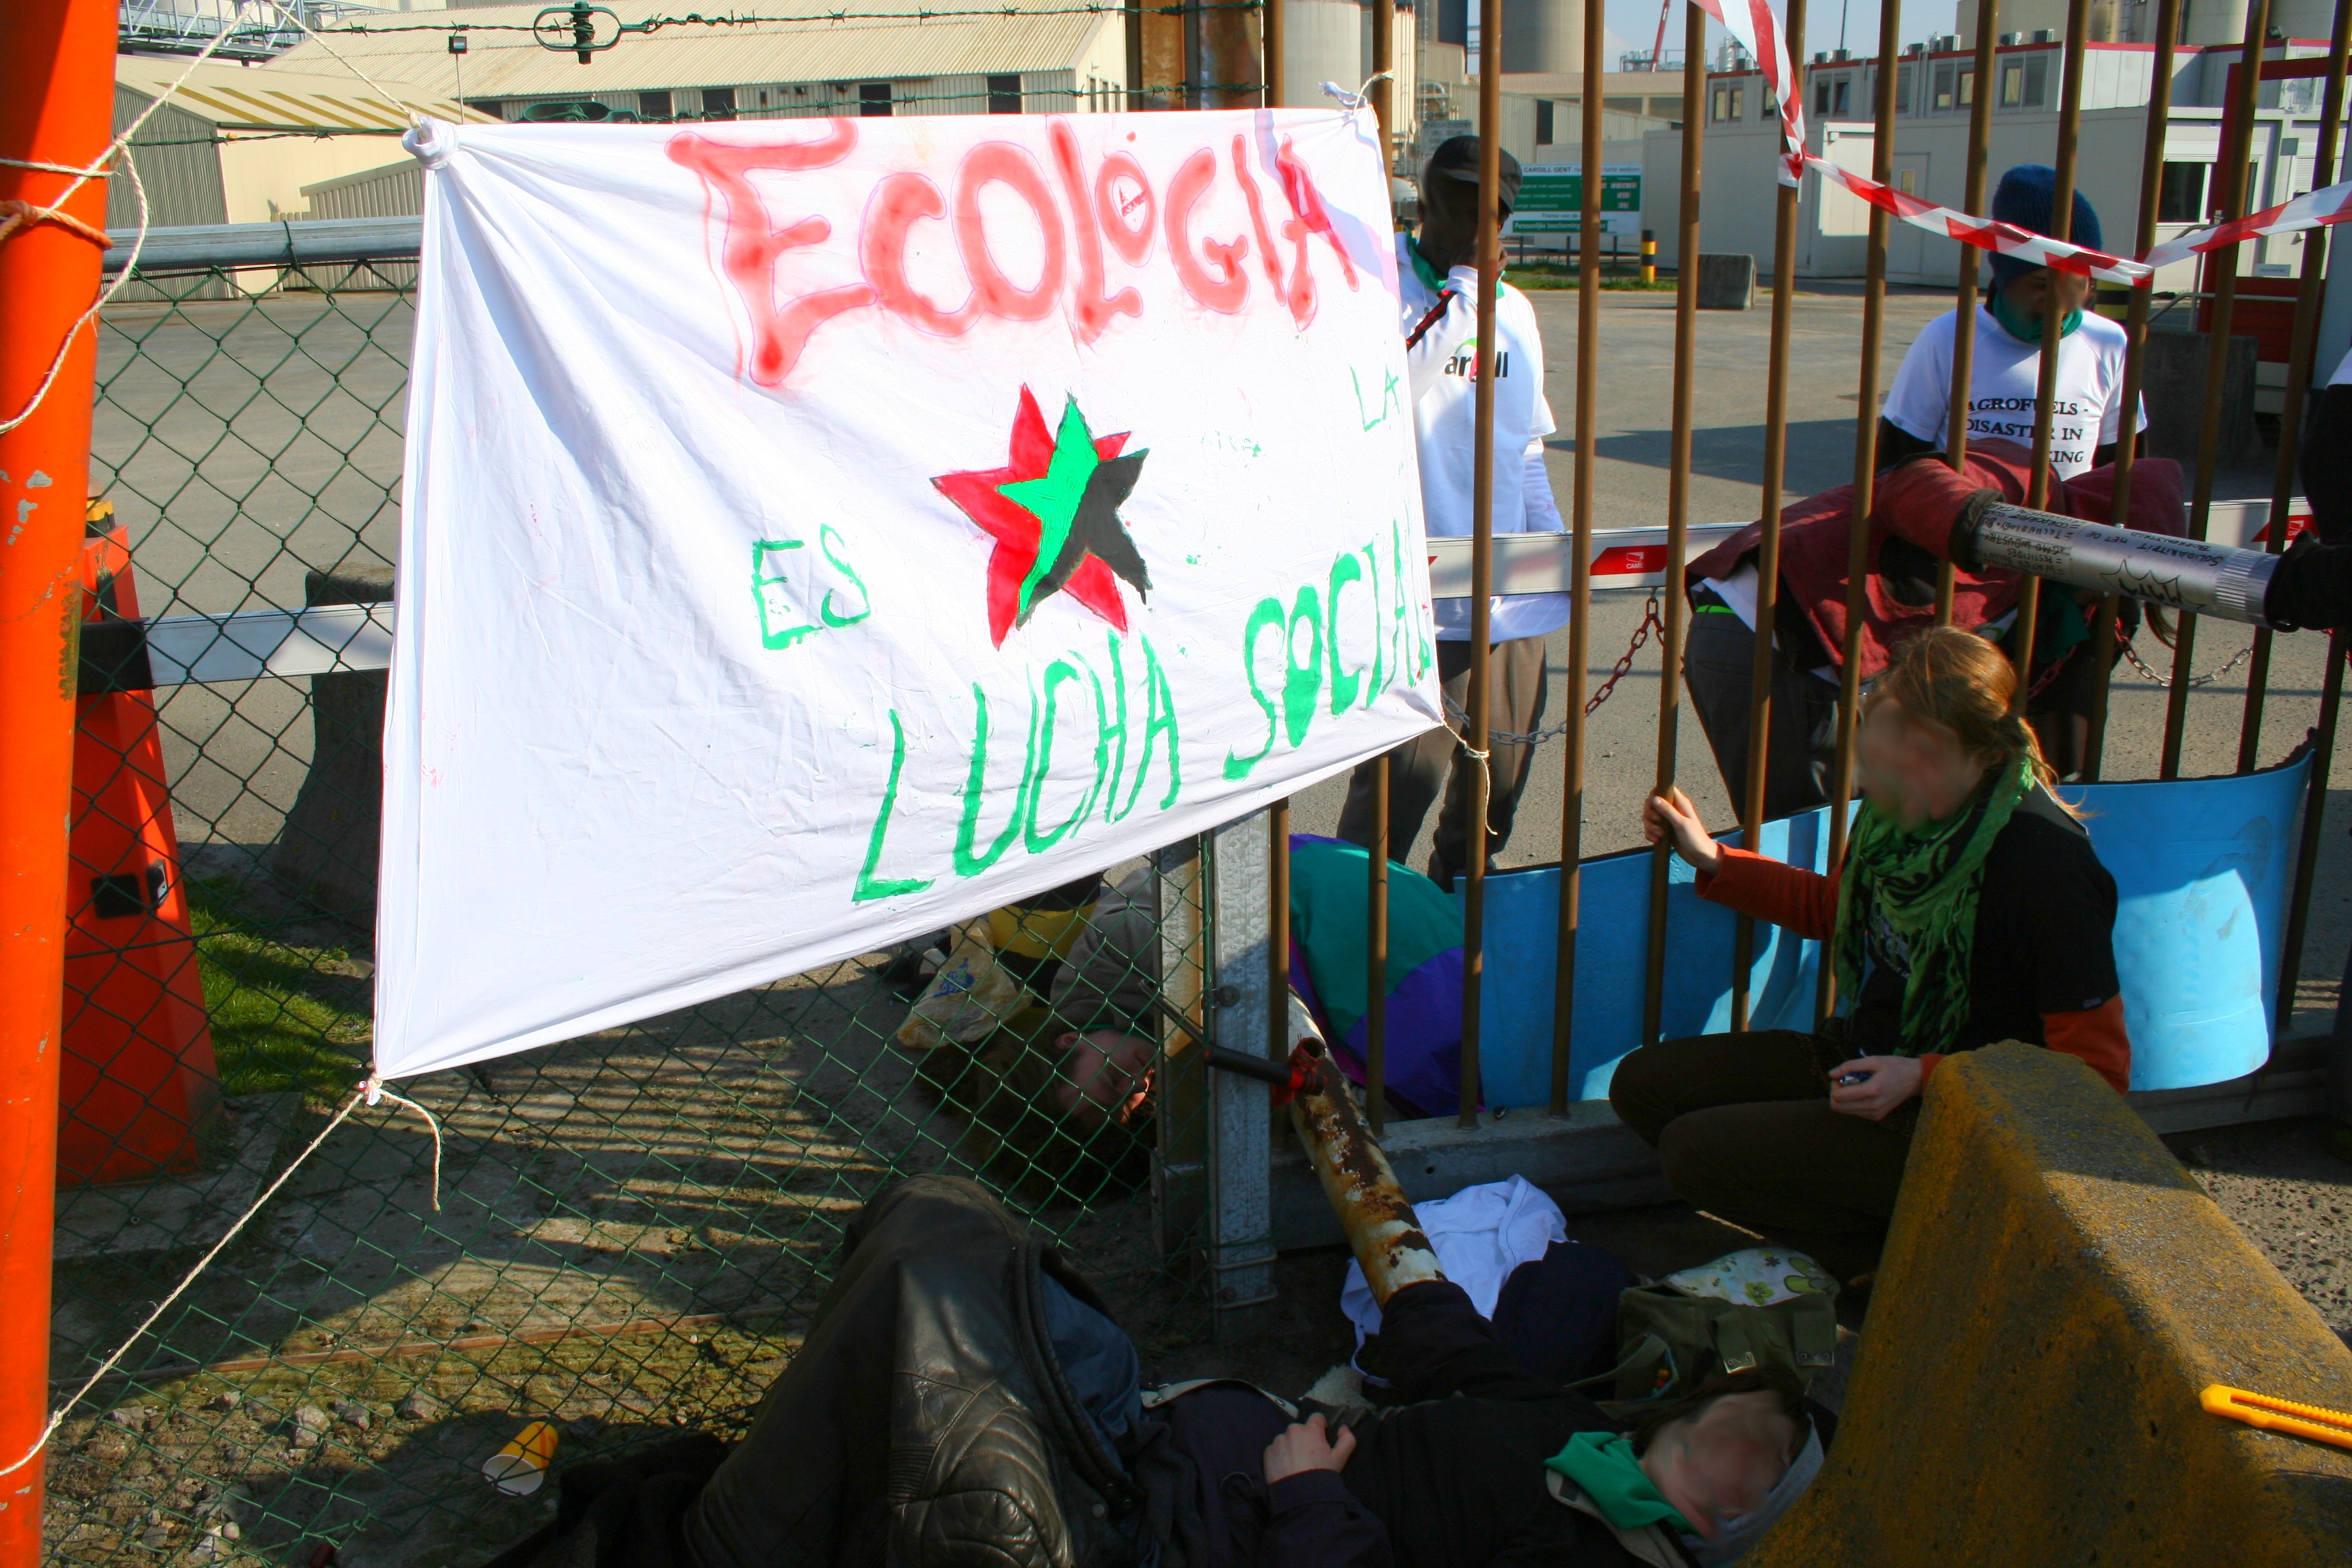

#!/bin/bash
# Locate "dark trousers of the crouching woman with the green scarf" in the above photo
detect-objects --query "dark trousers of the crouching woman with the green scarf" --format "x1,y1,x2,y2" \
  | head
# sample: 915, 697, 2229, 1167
1609, 1030, 1919, 1279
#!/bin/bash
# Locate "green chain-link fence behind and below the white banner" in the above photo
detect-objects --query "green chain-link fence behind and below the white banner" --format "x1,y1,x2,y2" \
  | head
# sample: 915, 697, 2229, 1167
47, 245, 1213, 1566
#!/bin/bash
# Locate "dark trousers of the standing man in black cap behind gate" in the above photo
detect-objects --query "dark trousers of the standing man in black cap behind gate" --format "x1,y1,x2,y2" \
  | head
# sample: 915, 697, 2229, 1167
1338, 637, 1546, 886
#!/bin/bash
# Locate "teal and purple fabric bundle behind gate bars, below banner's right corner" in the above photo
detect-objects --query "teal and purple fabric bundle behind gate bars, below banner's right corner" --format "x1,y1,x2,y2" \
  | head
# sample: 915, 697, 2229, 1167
1291, 832, 1463, 1119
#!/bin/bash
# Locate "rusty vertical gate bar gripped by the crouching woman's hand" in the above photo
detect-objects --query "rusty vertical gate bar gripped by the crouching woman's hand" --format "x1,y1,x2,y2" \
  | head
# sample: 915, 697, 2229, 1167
1646, 0, 1703, 1044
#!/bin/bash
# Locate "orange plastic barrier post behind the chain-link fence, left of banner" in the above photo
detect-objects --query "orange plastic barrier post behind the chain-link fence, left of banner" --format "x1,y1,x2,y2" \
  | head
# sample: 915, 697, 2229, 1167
56, 501, 221, 1185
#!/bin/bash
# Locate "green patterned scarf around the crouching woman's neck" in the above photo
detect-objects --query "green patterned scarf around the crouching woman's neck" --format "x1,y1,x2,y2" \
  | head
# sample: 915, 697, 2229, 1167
1837, 757, 2034, 1056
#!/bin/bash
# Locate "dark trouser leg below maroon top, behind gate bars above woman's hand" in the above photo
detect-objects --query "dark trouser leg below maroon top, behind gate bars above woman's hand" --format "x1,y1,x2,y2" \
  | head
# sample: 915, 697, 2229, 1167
1682, 609, 1837, 821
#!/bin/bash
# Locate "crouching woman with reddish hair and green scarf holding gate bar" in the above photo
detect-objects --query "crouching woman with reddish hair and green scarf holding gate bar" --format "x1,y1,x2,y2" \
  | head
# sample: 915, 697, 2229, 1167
1609, 627, 2131, 1279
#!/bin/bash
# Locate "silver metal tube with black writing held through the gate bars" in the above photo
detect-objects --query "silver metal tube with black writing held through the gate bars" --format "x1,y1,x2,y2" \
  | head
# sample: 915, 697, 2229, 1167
1952, 498, 2279, 625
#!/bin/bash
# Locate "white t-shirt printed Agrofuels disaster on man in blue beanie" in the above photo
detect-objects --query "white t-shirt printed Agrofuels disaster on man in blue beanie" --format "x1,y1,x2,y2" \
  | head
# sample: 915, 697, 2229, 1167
1879, 308, 2147, 480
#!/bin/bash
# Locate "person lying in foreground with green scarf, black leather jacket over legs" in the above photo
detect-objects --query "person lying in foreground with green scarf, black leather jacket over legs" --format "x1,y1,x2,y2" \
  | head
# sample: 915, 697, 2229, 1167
491, 1175, 1820, 1568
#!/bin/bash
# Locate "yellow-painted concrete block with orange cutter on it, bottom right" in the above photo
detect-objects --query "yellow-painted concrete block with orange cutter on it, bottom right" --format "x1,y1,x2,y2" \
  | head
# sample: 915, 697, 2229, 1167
1745, 1044, 2352, 1568
